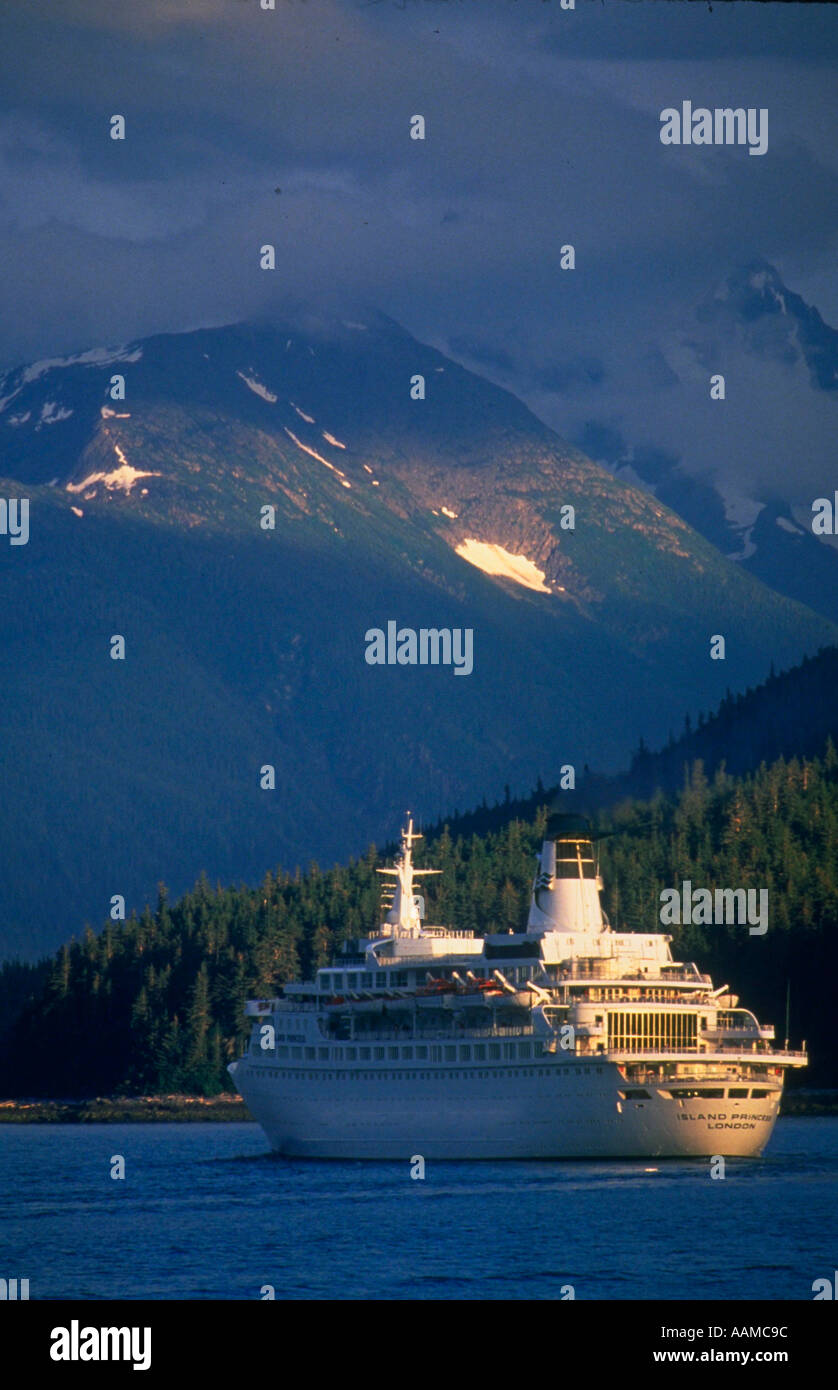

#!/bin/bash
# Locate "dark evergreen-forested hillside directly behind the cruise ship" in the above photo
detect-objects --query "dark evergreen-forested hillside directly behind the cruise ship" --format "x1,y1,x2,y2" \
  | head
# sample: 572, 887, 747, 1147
0, 741, 838, 1095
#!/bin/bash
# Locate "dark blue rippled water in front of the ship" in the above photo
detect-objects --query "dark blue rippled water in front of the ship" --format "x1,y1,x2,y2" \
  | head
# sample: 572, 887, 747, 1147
0, 1118, 838, 1300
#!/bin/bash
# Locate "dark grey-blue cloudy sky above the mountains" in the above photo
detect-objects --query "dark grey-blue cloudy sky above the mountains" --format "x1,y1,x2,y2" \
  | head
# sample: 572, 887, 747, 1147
0, 0, 838, 511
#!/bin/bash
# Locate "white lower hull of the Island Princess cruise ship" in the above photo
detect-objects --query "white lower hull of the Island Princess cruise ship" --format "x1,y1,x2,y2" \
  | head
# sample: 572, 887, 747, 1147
229, 1058, 781, 1161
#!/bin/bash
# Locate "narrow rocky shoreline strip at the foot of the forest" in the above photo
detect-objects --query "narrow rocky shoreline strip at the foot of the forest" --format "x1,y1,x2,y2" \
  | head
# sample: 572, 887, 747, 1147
0, 1088, 838, 1125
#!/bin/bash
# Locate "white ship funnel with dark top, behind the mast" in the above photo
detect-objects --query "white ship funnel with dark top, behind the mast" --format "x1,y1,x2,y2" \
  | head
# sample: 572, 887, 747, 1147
527, 815, 607, 933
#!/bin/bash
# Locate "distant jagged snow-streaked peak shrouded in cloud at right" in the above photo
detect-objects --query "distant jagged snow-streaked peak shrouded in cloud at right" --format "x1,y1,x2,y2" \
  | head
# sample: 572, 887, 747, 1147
573, 260, 838, 621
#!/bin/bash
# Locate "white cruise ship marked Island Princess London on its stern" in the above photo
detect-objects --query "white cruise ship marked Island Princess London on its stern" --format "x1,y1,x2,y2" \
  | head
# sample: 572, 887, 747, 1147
229, 816, 806, 1159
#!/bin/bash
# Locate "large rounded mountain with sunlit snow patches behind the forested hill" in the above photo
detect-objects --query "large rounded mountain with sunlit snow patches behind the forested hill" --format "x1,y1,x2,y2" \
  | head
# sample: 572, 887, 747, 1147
0, 316, 838, 956
